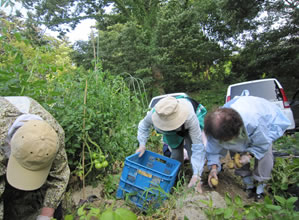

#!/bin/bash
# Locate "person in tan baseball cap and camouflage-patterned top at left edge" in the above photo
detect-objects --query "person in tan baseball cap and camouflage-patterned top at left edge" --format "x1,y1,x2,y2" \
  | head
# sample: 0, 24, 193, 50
0, 97, 70, 220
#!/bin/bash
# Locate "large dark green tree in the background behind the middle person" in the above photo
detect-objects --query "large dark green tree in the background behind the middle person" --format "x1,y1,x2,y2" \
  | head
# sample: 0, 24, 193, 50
71, 0, 247, 93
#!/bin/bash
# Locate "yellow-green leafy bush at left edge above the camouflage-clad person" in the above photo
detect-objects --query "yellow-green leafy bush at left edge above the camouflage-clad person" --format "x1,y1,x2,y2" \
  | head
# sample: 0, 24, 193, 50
0, 13, 74, 101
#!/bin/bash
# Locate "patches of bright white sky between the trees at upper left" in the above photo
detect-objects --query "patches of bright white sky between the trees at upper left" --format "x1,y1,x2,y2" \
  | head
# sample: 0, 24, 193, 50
1, 2, 96, 43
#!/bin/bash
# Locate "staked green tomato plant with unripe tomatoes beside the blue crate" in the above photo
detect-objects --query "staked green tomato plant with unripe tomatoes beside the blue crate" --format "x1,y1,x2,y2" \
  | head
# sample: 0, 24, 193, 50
47, 64, 146, 183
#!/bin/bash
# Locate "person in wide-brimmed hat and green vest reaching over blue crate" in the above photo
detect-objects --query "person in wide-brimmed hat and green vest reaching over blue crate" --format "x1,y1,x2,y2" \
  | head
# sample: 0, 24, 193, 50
136, 96, 205, 192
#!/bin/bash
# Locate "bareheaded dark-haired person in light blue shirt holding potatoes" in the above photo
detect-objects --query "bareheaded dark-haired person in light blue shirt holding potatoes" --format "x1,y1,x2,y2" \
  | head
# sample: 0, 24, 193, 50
204, 96, 290, 200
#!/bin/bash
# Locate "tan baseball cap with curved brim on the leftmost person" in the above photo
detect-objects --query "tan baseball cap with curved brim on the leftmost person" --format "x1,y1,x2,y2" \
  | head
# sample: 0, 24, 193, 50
6, 120, 59, 190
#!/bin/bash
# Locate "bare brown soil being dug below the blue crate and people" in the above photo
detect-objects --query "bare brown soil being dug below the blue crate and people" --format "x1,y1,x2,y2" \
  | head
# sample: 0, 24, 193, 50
66, 153, 253, 220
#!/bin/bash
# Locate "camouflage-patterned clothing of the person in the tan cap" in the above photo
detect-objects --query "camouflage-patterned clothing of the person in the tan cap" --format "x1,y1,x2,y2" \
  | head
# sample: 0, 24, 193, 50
0, 97, 70, 220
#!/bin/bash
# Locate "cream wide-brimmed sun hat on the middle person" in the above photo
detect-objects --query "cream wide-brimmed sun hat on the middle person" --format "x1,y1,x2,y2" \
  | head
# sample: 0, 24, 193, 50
152, 96, 189, 131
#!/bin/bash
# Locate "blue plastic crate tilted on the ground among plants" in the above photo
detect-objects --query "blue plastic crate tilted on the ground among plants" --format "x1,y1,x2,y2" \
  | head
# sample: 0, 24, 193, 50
116, 151, 181, 209
